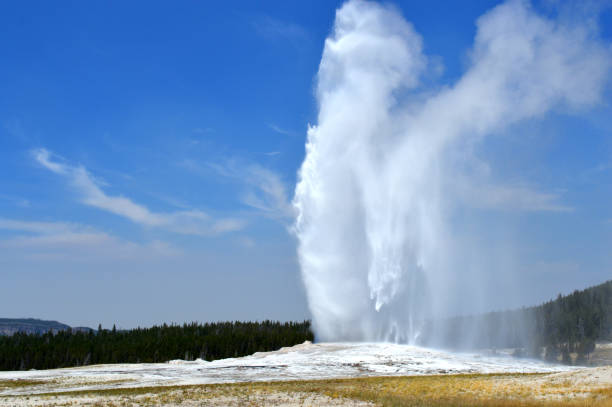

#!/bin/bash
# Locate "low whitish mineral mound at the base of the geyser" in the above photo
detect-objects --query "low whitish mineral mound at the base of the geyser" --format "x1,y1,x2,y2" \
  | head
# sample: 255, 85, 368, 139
0, 342, 571, 395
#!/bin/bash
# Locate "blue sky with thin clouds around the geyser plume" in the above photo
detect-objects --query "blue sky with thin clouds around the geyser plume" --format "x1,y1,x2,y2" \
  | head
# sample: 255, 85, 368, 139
0, 1, 612, 327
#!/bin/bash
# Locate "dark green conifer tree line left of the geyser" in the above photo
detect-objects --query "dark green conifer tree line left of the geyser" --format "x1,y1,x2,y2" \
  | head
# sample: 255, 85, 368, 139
0, 321, 313, 370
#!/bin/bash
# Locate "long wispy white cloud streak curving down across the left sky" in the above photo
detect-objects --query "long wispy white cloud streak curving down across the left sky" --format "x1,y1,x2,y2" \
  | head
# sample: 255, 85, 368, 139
32, 148, 245, 236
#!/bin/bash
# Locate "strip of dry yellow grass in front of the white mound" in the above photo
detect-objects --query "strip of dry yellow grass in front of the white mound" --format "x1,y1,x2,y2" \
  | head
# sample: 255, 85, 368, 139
0, 367, 612, 407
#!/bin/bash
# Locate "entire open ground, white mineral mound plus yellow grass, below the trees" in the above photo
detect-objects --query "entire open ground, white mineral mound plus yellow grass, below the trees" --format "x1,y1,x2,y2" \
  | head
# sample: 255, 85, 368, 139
0, 343, 612, 407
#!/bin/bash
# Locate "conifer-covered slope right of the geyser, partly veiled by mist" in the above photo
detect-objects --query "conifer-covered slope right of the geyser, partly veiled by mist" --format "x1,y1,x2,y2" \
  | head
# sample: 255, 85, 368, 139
423, 281, 612, 363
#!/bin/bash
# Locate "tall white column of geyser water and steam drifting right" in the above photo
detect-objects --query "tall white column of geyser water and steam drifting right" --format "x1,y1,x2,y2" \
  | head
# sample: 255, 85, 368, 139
294, 0, 611, 342
